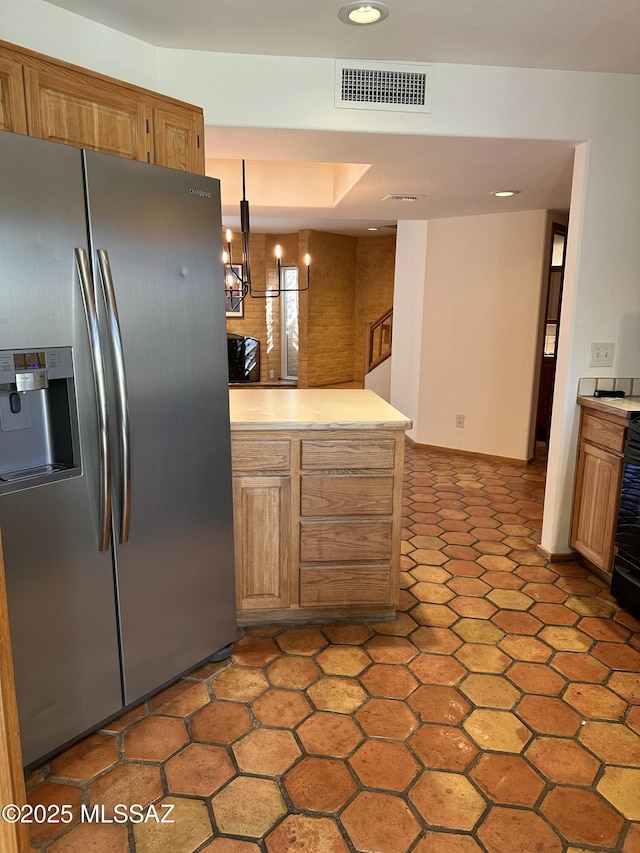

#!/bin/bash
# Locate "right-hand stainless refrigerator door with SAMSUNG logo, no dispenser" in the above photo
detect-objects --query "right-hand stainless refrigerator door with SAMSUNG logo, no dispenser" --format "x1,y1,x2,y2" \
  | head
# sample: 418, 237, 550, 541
84, 151, 235, 704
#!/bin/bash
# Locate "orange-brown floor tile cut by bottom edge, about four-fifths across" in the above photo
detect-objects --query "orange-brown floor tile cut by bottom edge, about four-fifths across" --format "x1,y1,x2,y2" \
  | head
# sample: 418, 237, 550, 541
478, 806, 564, 853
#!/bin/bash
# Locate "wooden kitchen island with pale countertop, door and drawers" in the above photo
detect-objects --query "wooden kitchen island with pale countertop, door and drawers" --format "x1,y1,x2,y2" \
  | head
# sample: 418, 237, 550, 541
229, 388, 411, 625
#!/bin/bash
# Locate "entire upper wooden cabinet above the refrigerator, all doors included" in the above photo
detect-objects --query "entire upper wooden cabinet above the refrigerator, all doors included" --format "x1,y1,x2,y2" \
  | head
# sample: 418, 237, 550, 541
0, 42, 204, 174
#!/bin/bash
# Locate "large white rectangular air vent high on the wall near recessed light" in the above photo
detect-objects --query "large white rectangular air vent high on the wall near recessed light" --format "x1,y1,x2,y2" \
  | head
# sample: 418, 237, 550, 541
335, 61, 431, 113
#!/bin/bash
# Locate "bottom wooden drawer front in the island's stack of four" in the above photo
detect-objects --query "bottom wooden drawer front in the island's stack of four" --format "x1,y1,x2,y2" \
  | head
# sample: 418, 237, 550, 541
300, 566, 393, 607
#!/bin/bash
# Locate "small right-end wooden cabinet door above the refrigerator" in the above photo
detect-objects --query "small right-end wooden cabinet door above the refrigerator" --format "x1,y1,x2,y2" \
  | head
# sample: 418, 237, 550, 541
152, 105, 204, 175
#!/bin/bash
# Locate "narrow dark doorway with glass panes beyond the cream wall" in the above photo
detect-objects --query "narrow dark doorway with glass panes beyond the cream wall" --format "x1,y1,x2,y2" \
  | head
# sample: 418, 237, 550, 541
536, 222, 567, 444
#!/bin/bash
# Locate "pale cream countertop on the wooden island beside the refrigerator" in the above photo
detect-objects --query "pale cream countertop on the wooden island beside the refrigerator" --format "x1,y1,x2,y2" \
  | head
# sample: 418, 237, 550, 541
229, 388, 411, 430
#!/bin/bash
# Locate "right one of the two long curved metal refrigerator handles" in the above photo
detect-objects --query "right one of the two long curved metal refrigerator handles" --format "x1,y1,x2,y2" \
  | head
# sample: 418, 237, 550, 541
97, 249, 131, 545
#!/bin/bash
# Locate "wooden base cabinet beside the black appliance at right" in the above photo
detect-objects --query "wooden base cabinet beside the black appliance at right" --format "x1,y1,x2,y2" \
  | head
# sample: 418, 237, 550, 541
570, 404, 628, 577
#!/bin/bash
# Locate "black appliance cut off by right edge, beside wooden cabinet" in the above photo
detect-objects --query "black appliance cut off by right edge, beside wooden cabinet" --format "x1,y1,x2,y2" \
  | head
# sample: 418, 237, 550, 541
611, 412, 640, 618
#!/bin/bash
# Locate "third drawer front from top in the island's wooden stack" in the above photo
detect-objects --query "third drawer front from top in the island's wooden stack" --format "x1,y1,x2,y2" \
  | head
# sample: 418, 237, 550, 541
300, 519, 392, 563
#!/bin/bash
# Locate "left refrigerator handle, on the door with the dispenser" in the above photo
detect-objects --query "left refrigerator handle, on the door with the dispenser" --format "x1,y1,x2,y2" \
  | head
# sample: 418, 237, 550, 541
75, 248, 111, 551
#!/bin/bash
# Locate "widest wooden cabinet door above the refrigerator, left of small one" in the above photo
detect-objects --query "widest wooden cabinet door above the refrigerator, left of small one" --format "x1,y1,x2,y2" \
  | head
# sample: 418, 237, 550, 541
25, 60, 151, 160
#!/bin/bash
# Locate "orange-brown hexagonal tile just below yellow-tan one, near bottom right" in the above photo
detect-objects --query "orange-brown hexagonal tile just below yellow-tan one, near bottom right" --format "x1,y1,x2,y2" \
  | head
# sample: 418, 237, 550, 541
470, 753, 545, 807
